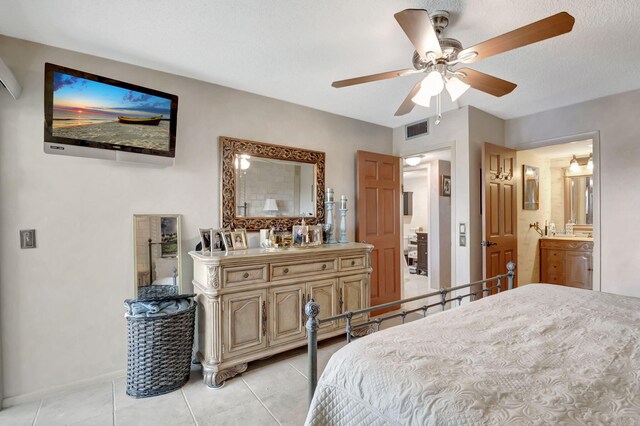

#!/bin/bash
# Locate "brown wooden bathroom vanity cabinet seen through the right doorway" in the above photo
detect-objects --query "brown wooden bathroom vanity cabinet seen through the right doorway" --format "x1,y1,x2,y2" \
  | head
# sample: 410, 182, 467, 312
540, 238, 593, 290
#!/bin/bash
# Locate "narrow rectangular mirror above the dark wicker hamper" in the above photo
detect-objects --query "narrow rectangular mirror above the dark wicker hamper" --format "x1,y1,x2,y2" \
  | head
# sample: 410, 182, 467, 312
133, 214, 182, 298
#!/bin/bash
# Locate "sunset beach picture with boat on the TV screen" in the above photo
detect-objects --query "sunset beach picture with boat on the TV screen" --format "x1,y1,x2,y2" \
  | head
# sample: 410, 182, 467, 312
52, 72, 171, 151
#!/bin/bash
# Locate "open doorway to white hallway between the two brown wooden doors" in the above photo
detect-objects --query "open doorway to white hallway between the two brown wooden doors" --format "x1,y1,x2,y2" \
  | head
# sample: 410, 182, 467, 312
400, 149, 453, 305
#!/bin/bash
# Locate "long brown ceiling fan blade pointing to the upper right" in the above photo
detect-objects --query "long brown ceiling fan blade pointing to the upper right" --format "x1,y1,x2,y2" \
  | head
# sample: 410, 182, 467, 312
458, 12, 576, 64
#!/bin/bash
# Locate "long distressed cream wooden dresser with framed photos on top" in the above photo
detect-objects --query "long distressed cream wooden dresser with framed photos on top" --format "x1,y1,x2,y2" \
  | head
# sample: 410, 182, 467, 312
189, 243, 373, 387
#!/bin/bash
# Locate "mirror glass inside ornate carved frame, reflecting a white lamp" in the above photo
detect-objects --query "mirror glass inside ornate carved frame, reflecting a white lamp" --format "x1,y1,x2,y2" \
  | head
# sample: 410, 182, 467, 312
234, 154, 316, 217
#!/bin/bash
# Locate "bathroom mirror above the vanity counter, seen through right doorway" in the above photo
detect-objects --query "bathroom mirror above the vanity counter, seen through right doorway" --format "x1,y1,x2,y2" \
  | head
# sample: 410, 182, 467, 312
564, 175, 593, 225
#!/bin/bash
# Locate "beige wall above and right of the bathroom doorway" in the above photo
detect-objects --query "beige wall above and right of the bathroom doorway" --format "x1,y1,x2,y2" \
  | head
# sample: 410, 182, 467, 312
506, 90, 640, 296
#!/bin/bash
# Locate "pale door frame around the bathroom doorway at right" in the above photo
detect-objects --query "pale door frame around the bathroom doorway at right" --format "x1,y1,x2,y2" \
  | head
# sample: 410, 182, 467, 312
508, 130, 602, 291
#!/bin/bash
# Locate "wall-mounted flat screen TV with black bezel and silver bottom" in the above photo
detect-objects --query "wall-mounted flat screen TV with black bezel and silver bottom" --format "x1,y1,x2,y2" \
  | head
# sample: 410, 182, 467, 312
44, 63, 178, 164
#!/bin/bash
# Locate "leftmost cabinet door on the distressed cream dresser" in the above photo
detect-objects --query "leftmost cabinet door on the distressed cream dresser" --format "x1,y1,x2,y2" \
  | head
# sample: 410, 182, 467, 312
222, 290, 267, 359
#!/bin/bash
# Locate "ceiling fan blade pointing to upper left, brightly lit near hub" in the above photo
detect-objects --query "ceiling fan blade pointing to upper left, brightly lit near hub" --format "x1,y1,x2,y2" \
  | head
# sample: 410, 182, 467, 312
393, 9, 442, 59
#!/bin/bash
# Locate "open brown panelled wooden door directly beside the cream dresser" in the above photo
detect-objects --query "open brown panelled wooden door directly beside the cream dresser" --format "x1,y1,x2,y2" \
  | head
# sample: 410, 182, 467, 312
356, 151, 402, 314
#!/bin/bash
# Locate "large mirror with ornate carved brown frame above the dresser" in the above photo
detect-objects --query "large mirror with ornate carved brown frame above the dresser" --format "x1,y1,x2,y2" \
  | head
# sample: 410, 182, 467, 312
220, 137, 325, 231
